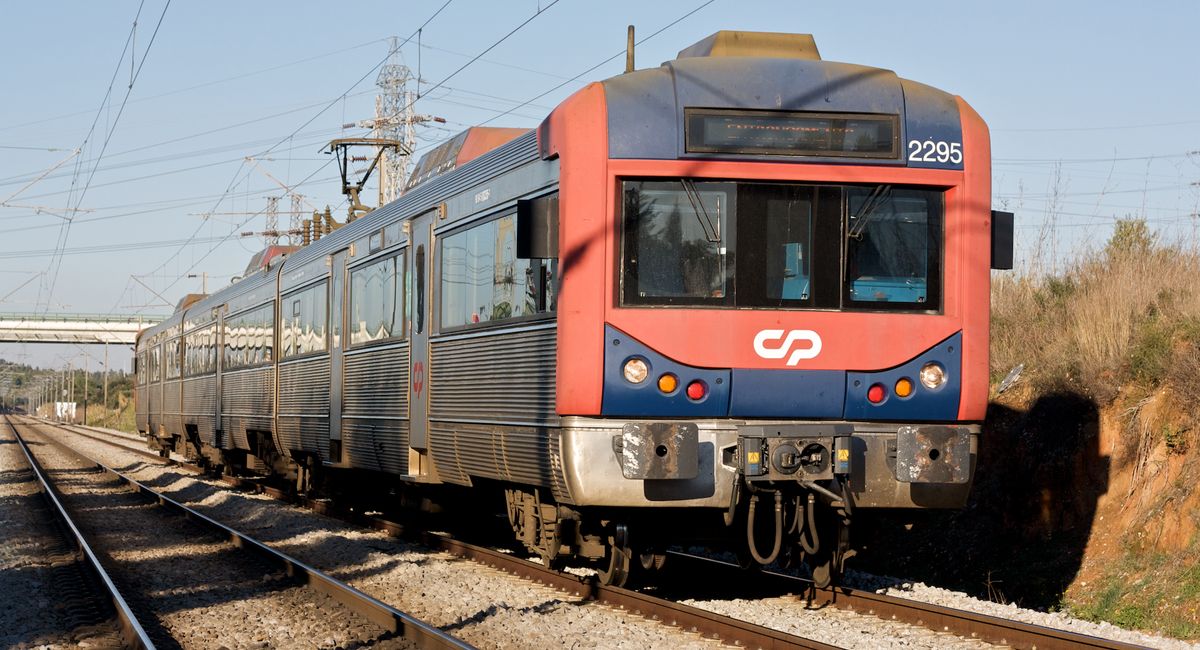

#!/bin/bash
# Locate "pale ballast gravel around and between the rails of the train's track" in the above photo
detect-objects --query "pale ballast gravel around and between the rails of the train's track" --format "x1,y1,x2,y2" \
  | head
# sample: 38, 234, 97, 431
51, 424, 1193, 650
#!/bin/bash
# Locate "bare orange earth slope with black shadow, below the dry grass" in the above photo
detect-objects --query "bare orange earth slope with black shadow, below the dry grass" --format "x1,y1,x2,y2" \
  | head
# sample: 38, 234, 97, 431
856, 387, 1200, 639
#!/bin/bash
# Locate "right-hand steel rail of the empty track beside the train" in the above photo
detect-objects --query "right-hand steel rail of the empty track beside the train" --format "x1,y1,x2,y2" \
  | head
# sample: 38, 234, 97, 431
15, 417, 474, 650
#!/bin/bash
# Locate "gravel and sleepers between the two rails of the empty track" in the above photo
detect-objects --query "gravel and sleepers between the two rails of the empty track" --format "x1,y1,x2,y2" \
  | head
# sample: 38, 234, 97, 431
14, 428, 413, 649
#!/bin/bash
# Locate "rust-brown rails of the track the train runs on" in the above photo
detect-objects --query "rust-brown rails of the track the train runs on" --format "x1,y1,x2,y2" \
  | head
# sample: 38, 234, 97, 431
42, 419, 1139, 649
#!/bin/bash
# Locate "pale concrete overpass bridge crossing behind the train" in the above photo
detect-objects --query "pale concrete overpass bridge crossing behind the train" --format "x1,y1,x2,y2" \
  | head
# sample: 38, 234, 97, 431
0, 313, 163, 345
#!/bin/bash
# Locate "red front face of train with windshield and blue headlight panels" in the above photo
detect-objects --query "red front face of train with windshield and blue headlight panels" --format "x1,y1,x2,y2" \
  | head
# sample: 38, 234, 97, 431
542, 84, 990, 421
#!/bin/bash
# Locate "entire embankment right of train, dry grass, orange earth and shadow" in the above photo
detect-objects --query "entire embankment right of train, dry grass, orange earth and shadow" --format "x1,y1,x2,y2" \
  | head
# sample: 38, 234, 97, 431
858, 221, 1200, 640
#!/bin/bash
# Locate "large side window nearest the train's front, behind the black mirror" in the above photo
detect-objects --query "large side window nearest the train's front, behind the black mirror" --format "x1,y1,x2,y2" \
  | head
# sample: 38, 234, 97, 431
438, 215, 558, 330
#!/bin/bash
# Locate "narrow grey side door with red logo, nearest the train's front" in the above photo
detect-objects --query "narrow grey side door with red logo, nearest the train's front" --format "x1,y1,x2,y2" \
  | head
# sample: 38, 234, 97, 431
408, 210, 437, 477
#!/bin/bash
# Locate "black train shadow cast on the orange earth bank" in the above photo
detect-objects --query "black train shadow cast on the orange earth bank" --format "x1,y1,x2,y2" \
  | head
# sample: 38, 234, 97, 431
850, 392, 1110, 609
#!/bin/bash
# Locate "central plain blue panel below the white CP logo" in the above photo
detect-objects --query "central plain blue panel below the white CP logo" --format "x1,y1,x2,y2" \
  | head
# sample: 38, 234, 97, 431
730, 368, 846, 417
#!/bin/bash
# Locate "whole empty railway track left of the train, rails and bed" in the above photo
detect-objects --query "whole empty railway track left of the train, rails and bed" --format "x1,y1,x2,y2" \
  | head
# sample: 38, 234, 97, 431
6, 419, 470, 649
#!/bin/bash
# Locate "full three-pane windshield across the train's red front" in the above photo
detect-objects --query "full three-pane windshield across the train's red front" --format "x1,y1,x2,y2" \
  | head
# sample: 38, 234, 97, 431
622, 179, 943, 312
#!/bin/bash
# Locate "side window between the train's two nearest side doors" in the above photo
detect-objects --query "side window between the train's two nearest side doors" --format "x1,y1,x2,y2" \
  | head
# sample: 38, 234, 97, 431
350, 253, 406, 345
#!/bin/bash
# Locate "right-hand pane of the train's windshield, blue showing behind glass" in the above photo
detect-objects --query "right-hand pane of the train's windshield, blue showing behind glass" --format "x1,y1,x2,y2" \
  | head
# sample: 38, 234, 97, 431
845, 185, 942, 309
